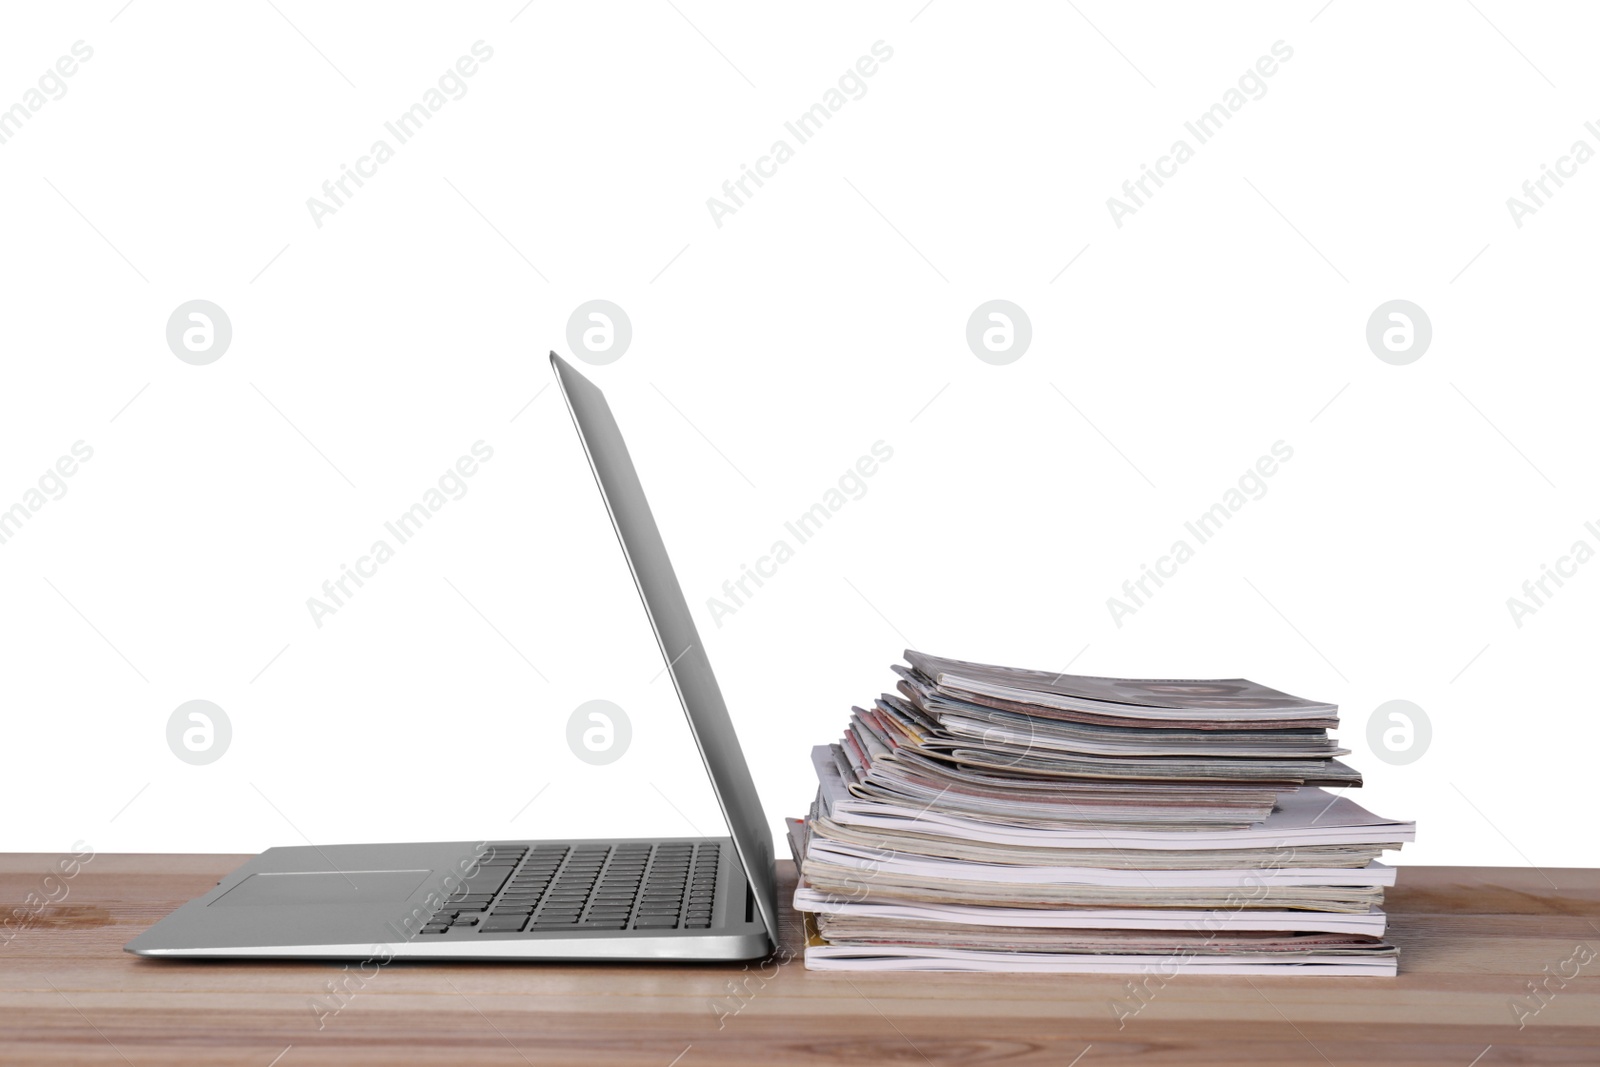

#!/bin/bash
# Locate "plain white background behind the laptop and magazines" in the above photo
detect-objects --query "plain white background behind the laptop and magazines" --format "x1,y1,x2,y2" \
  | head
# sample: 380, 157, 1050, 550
0, 0, 1600, 867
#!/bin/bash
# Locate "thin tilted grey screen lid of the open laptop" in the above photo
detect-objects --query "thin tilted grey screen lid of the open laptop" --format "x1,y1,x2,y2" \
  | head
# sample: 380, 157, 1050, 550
550, 352, 778, 945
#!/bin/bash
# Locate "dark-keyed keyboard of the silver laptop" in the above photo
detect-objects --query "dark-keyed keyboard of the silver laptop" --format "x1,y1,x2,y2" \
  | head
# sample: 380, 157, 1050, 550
421, 841, 720, 934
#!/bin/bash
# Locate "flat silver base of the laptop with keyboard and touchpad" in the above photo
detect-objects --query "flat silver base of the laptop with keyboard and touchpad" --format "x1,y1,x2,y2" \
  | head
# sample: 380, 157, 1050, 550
126, 838, 773, 963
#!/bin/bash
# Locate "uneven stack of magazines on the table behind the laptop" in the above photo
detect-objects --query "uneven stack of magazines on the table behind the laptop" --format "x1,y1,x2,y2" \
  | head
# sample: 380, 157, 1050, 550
789, 649, 1416, 976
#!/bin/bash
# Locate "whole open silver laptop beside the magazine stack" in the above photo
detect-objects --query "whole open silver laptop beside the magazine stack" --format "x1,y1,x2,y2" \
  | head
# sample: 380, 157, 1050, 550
126, 352, 778, 961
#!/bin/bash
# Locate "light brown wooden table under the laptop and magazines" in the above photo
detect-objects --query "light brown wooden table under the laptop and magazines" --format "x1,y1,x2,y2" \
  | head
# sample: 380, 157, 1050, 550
0, 854, 1600, 1067
